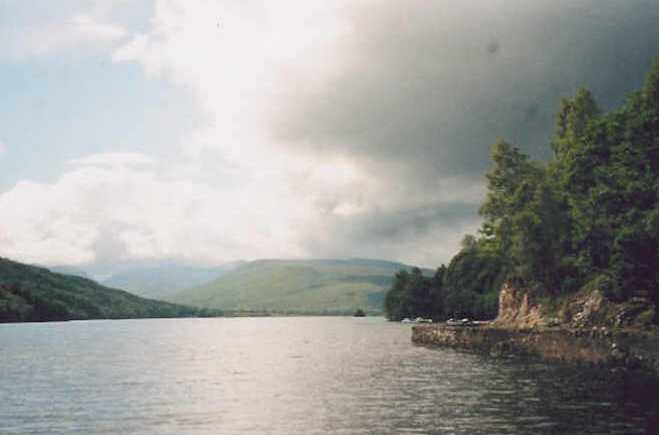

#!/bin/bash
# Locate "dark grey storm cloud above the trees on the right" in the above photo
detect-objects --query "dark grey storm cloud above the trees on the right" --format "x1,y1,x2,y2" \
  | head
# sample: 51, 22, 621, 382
271, 0, 659, 262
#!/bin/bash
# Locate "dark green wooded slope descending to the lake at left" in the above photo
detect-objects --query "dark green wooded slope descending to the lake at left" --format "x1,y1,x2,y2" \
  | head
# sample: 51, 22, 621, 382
0, 258, 220, 322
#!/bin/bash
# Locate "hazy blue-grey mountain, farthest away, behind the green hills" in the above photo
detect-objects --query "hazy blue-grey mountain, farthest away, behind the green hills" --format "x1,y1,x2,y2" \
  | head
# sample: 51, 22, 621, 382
101, 262, 243, 299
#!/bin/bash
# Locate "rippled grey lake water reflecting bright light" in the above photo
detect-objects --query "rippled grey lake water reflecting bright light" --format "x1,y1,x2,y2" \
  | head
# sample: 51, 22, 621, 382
0, 317, 657, 434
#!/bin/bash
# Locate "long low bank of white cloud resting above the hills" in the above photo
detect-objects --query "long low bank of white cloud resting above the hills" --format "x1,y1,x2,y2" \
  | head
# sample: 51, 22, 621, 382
0, 145, 474, 265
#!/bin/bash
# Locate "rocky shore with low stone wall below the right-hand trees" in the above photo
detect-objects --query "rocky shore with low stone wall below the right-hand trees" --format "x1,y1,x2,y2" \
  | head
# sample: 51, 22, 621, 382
412, 283, 659, 375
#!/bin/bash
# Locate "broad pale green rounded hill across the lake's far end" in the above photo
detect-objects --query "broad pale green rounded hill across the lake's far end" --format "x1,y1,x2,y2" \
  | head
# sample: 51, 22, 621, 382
170, 259, 432, 314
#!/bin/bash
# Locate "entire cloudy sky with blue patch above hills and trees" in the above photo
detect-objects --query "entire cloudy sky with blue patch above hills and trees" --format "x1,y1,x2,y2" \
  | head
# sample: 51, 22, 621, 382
0, 0, 659, 269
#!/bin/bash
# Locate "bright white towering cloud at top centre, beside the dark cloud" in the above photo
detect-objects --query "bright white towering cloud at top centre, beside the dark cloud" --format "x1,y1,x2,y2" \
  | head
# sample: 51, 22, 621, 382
113, 0, 351, 164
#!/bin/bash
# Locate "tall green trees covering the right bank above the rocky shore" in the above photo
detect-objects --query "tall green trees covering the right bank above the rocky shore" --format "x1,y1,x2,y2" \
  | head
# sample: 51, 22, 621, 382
385, 59, 659, 323
